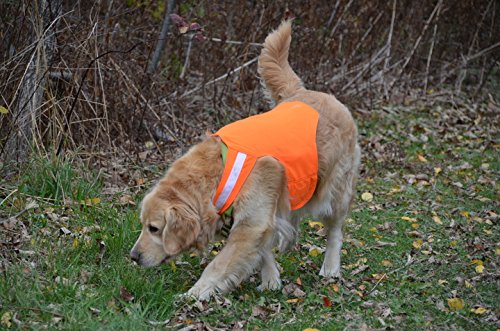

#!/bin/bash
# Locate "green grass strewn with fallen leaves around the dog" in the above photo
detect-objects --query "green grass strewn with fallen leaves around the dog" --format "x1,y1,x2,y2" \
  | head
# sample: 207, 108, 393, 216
0, 103, 500, 330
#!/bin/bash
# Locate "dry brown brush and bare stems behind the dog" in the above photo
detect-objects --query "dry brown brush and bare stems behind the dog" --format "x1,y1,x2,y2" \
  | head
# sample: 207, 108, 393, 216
0, 0, 500, 164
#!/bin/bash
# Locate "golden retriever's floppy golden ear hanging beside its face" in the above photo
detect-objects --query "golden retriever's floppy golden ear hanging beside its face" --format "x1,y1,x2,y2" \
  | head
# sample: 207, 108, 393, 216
162, 205, 200, 256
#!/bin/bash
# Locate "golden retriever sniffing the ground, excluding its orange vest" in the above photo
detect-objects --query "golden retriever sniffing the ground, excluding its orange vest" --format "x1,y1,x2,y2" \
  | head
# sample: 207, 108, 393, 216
130, 20, 361, 300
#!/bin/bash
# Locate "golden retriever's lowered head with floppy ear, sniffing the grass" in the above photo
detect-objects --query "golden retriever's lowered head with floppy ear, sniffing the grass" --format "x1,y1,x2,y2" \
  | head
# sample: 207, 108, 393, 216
130, 189, 200, 267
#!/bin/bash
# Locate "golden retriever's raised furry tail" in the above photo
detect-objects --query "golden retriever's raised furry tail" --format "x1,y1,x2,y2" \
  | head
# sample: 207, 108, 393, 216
258, 20, 304, 103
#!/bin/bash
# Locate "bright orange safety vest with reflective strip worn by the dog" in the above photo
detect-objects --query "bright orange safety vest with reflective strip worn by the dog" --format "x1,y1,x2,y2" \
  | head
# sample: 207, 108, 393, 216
213, 101, 319, 214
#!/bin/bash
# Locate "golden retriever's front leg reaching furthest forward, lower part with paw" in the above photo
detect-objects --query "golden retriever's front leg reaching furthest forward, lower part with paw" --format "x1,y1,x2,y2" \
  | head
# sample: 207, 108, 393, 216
188, 221, 279, 300
